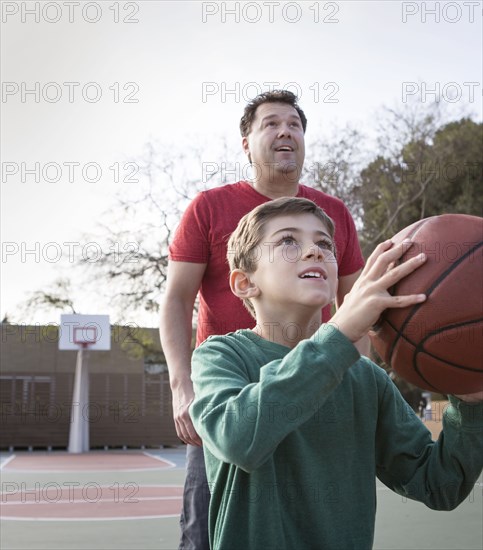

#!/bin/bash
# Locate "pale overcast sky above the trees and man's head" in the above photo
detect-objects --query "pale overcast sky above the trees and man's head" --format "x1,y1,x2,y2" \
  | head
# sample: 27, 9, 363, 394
0, 1, 482, 326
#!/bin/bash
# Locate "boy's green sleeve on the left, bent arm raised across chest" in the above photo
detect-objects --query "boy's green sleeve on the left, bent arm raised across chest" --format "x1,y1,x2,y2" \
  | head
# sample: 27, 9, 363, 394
190, 325, 359, 472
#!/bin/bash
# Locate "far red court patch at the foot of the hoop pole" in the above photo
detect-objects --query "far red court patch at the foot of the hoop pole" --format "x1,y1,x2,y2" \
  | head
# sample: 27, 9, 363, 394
2, 451, 173, 472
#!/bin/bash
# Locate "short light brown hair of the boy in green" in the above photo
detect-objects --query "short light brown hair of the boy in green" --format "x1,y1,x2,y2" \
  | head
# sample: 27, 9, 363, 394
227, 197, 335, 318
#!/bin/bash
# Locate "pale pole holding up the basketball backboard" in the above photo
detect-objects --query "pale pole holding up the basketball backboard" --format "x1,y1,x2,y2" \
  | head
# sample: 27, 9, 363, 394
68, 343, 89, 453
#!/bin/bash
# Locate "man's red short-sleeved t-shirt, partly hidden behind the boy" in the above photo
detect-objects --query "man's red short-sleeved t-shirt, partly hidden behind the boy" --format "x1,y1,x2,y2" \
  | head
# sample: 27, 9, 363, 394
169, 181, 364, 345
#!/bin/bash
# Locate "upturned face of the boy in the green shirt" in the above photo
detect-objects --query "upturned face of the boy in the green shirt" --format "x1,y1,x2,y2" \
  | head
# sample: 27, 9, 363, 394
249, 214, 337, 315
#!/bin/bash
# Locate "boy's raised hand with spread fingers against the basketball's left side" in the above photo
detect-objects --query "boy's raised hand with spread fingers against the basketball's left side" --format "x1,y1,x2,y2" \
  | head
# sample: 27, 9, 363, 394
330, 240, 426, 342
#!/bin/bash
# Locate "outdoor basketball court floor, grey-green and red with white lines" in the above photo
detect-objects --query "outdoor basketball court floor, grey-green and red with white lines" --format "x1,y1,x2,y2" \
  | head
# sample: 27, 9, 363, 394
0, 436, 483, 550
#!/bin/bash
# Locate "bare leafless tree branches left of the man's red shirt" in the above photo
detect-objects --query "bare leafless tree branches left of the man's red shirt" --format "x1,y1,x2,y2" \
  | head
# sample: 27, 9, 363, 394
81, 140, 246, 324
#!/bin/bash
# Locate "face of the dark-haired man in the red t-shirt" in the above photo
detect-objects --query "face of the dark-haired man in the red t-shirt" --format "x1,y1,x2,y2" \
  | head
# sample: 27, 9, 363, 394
242, 103, 305, 183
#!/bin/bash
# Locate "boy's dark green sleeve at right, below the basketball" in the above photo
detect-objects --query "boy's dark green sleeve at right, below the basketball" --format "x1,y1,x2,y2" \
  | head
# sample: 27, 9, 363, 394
376, 375, 483, 510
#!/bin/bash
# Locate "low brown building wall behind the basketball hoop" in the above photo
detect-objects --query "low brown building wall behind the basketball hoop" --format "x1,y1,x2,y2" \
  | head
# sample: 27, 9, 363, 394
0, 324, 180, 449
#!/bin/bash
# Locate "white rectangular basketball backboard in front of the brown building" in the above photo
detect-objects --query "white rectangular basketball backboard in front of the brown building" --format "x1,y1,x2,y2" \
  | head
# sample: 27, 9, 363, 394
59, 315, 111, 351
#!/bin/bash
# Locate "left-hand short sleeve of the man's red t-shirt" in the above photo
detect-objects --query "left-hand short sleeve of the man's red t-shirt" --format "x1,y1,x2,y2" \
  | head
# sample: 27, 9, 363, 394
169, 192, 210, 264
